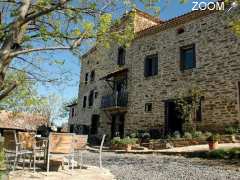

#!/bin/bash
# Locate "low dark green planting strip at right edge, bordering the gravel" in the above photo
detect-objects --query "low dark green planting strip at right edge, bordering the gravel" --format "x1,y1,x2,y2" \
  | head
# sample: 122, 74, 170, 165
208, 148, 240, 159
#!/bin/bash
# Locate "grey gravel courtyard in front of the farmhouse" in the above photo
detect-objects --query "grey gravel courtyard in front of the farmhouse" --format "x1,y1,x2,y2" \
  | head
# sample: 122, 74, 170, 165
83, 152, 240, 180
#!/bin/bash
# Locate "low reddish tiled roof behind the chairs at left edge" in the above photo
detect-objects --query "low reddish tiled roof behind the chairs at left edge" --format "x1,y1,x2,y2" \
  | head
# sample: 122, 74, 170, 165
0, 111, 48, 131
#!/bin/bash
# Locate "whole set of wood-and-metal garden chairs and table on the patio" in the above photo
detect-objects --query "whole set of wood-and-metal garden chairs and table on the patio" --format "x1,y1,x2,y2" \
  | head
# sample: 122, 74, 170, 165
3, 130, 105, 172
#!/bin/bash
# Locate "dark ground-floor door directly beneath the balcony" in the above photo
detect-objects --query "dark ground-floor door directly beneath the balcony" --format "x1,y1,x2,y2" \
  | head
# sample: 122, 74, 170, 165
111, 113, 125, 138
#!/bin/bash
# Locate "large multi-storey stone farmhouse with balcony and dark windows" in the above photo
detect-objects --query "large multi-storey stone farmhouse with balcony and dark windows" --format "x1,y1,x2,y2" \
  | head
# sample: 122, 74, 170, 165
71, 9, 240, 137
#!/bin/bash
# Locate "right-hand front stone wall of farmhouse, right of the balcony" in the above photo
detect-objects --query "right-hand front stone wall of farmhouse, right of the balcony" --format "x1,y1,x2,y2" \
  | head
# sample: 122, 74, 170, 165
125, 10, 240, 133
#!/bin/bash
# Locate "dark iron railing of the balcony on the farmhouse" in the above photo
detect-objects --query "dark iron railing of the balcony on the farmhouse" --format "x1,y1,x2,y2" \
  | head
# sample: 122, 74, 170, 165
101, 92, 128, 108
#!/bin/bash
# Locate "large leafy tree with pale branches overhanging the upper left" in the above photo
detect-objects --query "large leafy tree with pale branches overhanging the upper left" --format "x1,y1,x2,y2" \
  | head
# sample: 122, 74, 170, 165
0, 0, 163, 100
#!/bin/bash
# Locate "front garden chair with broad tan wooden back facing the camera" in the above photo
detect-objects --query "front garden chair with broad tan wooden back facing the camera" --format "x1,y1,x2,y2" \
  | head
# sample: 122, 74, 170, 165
47, 133, 75, 172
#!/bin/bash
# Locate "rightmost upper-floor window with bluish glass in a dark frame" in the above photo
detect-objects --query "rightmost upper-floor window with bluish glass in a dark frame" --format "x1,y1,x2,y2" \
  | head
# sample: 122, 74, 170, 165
180, 44, 196, 71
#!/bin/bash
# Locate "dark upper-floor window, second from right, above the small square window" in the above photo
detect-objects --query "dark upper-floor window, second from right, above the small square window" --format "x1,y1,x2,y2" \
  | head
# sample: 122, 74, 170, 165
144, 54, 158, 77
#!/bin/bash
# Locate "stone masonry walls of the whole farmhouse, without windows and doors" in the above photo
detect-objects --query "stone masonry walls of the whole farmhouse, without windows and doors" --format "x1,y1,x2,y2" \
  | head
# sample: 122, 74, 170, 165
76, 8, 240, 138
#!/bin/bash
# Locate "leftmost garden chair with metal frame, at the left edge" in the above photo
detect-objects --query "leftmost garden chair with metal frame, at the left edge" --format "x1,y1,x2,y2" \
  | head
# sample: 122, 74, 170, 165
3, 130, 35, 171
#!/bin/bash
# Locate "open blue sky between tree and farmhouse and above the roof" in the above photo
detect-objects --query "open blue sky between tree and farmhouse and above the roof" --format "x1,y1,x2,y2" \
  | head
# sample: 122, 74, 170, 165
38, 0, 214, 124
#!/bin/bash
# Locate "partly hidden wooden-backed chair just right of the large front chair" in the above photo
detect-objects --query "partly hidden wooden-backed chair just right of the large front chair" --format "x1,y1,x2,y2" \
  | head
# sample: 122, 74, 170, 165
74, 135, 88, 168
